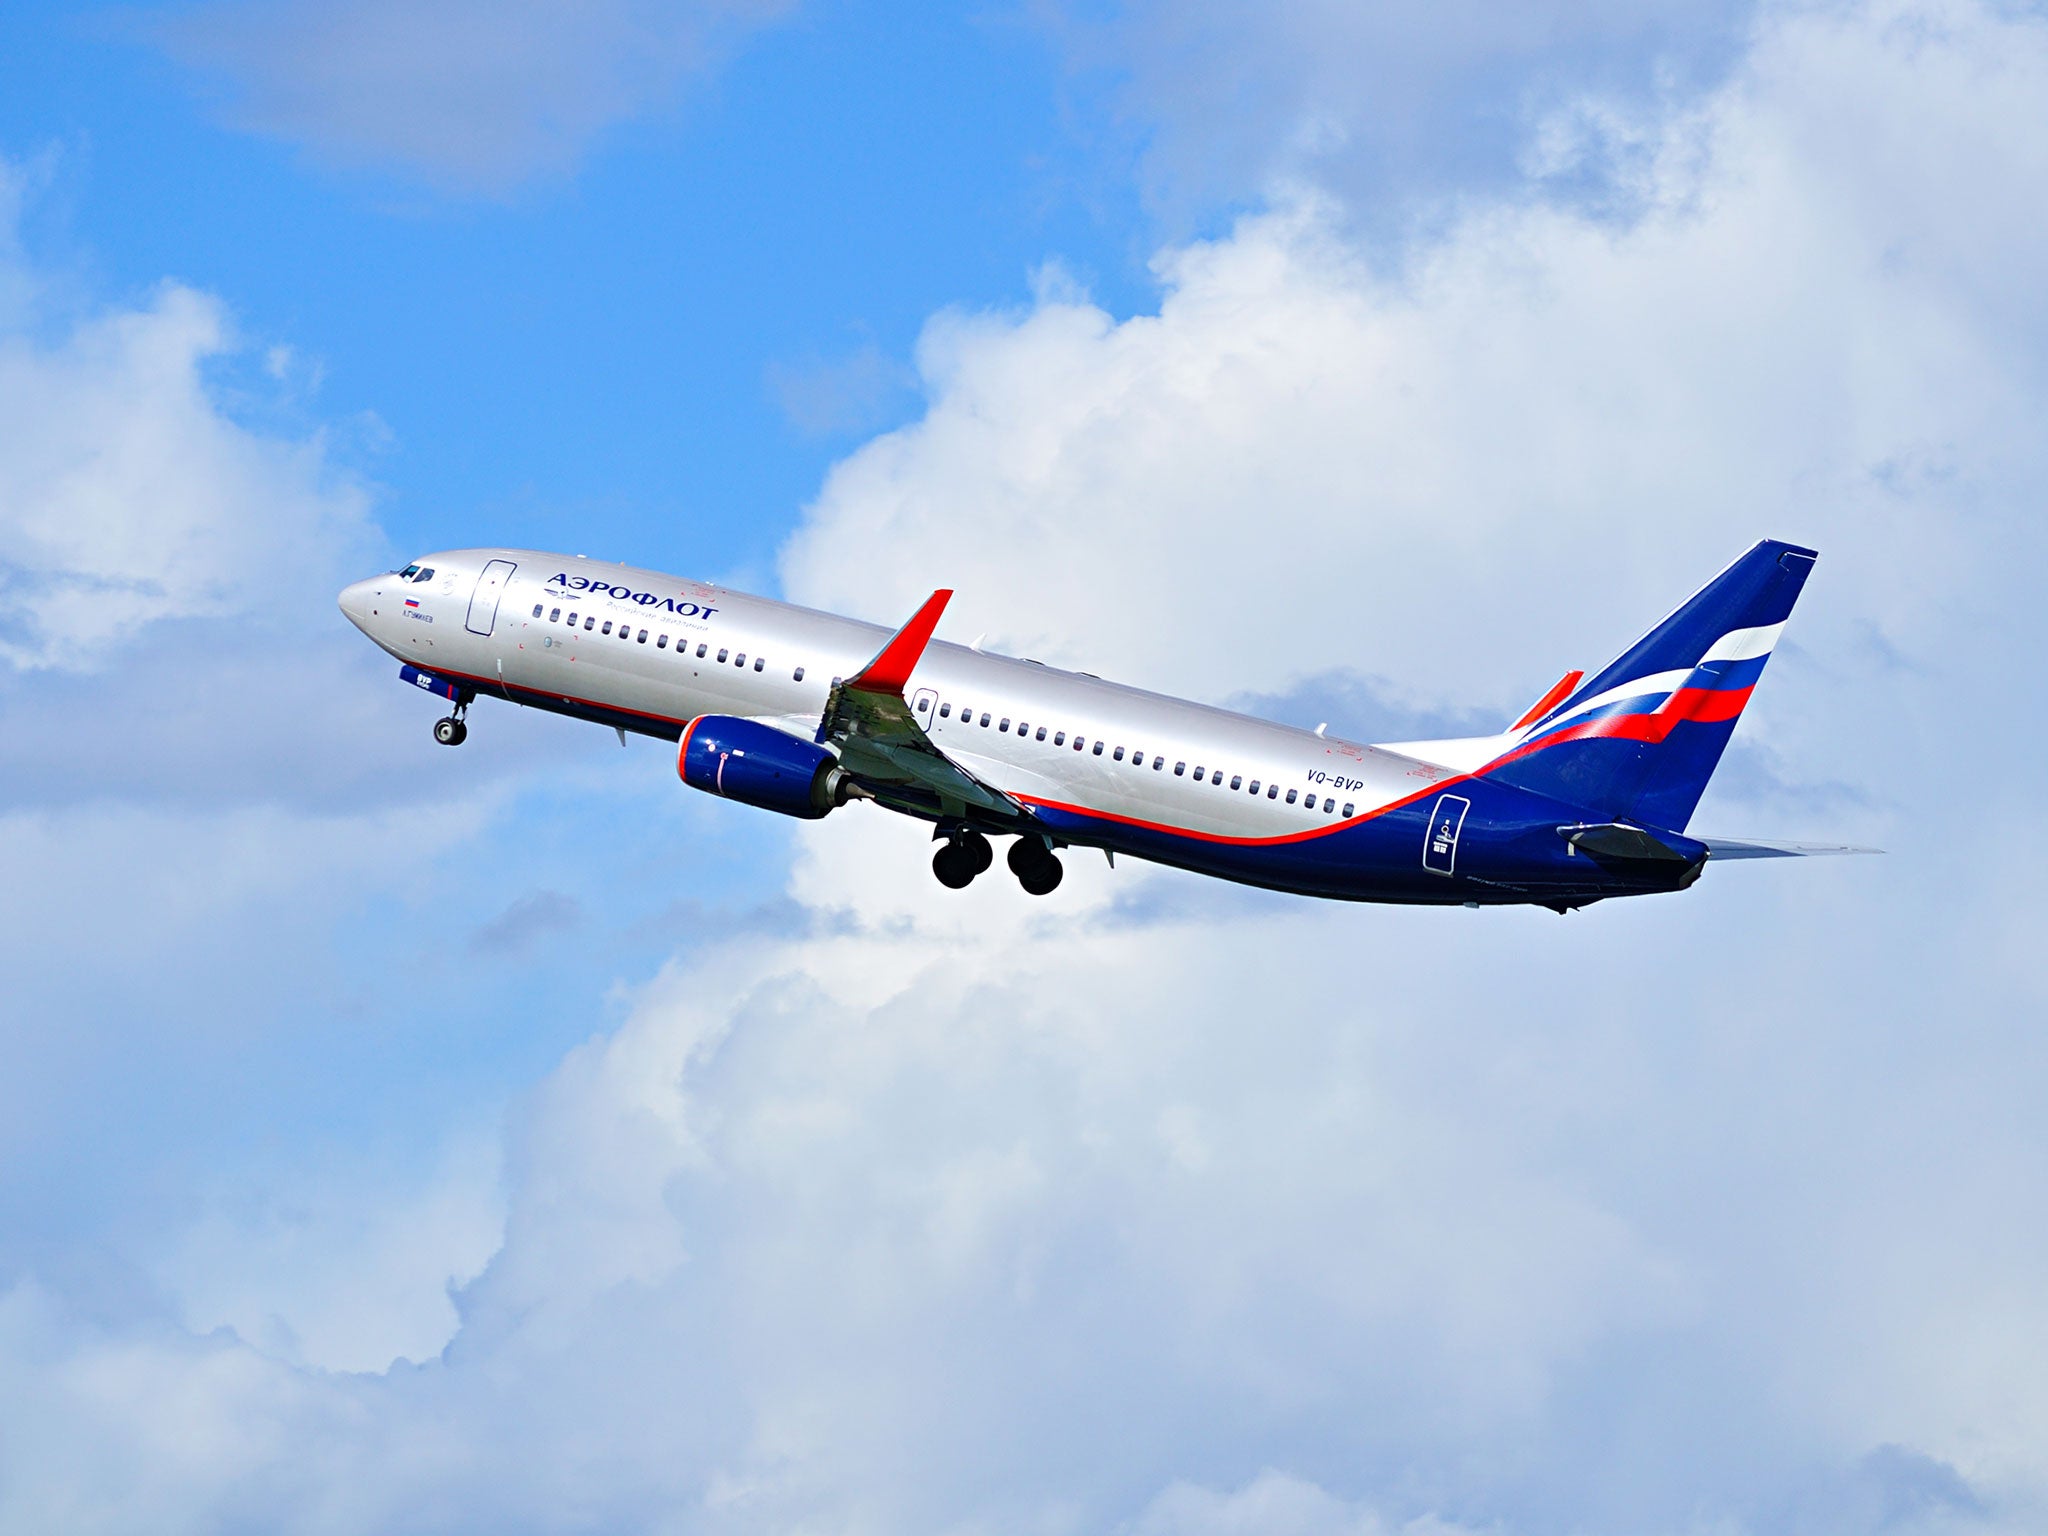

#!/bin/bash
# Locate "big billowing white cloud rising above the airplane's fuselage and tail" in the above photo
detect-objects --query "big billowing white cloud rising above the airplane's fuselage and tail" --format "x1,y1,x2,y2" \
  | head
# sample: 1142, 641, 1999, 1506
784, 0, 2048, 749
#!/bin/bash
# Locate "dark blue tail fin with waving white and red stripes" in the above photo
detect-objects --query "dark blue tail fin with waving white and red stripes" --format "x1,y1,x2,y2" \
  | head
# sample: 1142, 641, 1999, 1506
1483, 539, 1819, 831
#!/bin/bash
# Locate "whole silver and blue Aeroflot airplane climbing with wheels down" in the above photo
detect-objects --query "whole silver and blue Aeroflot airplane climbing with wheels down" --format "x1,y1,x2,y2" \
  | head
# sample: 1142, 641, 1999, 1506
340, 539, 1874, 913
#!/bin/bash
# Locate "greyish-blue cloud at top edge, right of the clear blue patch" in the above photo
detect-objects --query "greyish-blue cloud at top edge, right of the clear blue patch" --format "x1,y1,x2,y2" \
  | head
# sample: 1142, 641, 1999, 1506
1038, 0, 1757, 227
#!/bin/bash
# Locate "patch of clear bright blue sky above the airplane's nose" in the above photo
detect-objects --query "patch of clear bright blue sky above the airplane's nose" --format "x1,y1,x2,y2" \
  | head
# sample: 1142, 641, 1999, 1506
4, 4, 1171, 569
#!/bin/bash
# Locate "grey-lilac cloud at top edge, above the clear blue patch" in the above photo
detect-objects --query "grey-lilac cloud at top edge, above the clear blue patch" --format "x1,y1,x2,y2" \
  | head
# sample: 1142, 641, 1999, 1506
156, 0, 788, 190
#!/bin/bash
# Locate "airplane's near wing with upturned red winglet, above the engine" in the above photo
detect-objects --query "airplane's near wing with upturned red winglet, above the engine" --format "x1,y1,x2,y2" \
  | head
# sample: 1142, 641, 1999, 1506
817, 588, 1032, 821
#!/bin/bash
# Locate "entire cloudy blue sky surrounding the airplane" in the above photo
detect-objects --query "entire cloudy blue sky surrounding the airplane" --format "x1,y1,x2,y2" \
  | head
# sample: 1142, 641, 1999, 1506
0, 0, 2048, 1536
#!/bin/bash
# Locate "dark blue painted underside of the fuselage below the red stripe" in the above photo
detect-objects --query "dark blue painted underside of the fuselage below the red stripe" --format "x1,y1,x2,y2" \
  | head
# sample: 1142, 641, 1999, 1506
442, 674, 1694, 907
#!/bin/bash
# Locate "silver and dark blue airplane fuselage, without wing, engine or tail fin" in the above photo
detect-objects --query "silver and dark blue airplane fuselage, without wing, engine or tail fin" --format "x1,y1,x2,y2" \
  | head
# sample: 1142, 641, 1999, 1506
340, 549, 1843, 907
